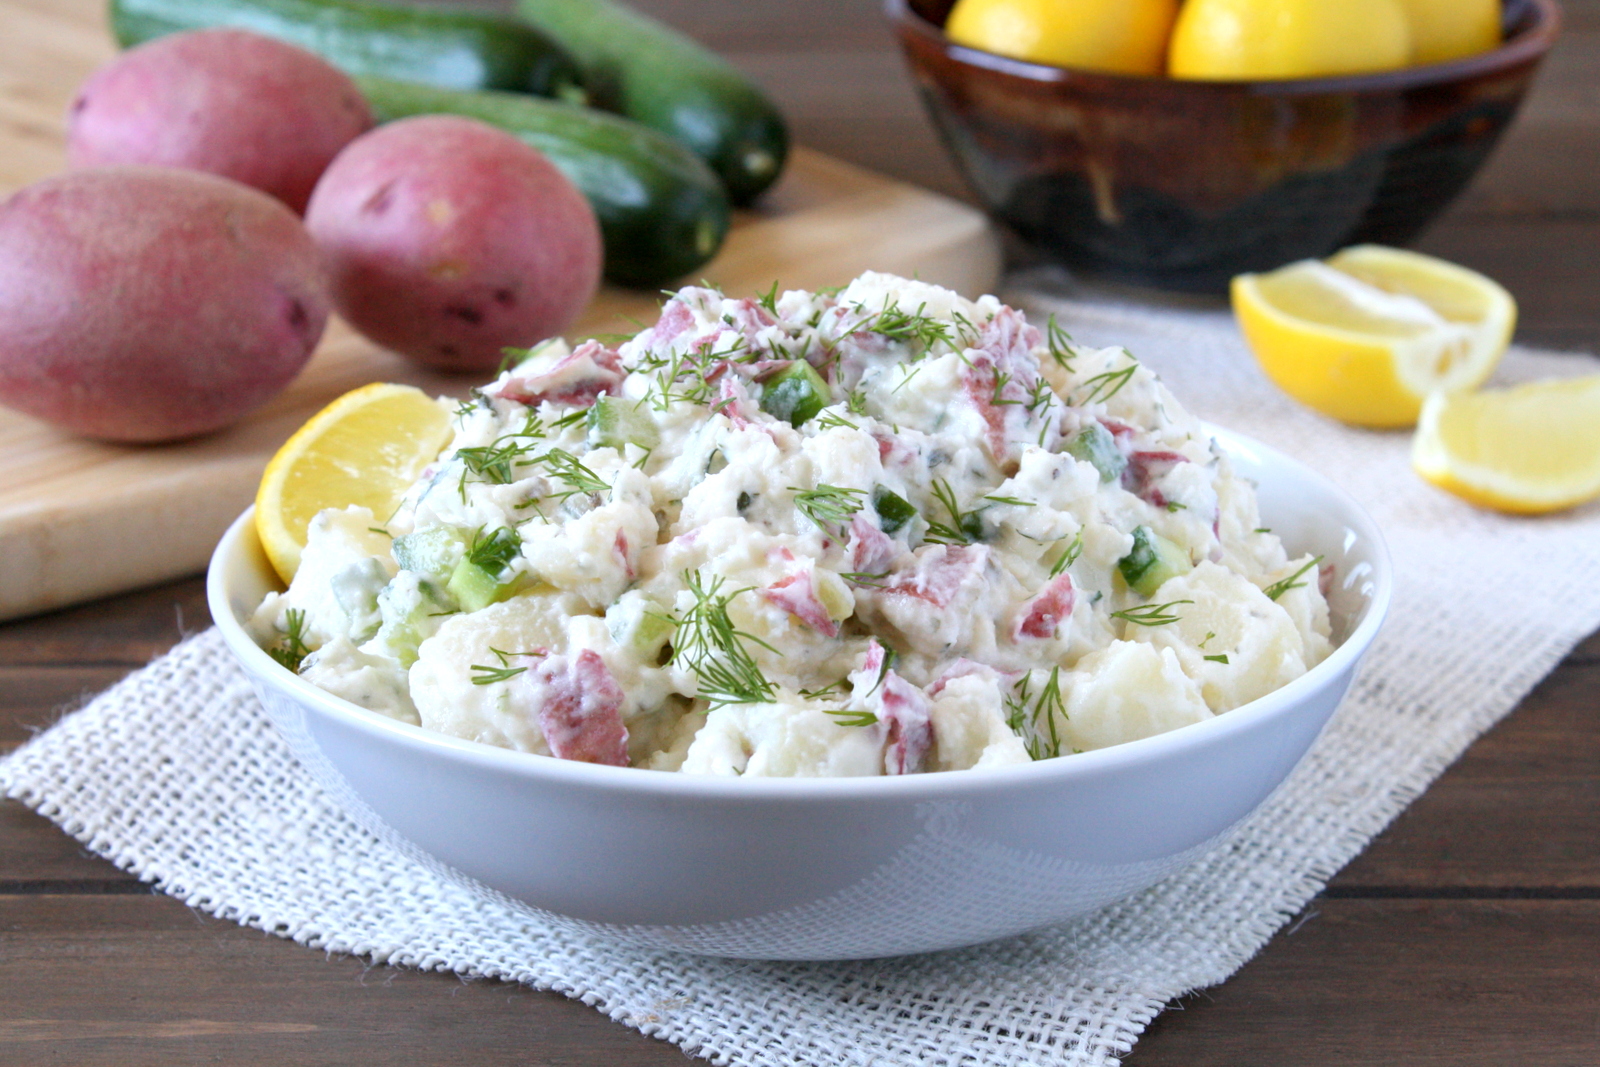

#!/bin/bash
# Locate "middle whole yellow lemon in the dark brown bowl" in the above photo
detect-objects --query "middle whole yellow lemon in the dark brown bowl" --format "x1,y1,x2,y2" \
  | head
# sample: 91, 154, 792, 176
1166, 0, 1411, 82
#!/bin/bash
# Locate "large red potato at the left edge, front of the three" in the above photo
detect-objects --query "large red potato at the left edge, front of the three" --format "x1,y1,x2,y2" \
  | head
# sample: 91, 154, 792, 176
0, 166, 328, 442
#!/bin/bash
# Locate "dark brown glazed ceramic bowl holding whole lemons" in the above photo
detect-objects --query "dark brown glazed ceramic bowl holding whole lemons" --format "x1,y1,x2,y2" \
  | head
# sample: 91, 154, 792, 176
885, 0, 1562, 291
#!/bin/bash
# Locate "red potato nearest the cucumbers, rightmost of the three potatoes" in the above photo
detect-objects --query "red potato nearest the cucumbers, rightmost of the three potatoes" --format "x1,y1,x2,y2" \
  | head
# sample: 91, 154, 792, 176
306, 115, 602, 374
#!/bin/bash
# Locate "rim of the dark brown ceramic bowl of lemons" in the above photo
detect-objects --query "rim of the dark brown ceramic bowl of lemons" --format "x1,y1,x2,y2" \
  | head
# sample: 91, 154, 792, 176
883, 0, 1563, 96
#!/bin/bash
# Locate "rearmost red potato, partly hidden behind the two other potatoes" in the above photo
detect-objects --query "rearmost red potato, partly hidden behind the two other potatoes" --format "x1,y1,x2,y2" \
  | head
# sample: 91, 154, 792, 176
67, 29, 373, 213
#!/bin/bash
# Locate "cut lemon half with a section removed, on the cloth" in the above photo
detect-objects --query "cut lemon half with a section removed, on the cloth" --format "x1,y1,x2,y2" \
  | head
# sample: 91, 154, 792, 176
1234, 245, 1517, 427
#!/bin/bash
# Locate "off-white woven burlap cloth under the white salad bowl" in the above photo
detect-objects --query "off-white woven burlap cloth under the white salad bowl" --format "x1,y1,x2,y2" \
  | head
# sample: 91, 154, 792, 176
9, 278, 1600, 1067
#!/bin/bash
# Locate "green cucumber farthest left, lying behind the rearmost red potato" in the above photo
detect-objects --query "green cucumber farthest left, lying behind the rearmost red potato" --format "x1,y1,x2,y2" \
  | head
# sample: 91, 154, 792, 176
110, 0, 586, 99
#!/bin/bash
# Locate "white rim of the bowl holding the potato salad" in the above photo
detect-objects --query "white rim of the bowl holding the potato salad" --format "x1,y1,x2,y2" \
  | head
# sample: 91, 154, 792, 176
206, 422, 1394, 803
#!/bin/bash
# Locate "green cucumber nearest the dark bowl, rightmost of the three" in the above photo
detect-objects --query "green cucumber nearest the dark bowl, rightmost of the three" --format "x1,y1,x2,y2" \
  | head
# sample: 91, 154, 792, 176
517, 0, 789, 206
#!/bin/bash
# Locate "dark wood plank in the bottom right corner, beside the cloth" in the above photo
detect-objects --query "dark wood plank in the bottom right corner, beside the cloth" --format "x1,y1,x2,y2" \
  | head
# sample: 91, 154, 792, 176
1126, 901, 1600, 1067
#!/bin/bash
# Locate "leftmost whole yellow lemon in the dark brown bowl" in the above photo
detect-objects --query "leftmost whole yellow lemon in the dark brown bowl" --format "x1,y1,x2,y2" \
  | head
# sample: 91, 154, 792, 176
944, 0, 1178, 75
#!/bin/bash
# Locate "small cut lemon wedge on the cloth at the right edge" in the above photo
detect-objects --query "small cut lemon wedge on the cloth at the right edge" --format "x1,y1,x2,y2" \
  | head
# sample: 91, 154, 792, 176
1411, 374, 1600, 515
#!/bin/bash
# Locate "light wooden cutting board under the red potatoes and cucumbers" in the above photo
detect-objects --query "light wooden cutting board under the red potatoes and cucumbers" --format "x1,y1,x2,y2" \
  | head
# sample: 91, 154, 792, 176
0, 0, 1000, 619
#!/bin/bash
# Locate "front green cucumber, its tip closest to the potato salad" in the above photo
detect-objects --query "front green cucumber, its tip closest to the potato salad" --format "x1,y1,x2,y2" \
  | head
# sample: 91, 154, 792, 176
355, 77, 730, 290
